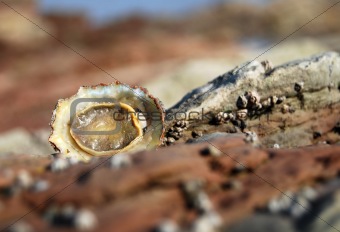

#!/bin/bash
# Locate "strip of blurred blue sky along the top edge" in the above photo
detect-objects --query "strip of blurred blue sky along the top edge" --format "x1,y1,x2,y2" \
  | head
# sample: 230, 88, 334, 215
39, 0, 270, 23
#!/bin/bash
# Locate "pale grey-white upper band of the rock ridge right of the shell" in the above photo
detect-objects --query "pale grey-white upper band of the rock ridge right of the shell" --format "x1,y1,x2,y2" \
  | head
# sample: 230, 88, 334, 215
168, 52, 340, 117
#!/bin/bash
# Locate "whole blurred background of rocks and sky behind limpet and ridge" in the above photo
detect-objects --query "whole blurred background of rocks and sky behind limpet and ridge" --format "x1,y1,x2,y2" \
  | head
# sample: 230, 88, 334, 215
0, 0, 340, 155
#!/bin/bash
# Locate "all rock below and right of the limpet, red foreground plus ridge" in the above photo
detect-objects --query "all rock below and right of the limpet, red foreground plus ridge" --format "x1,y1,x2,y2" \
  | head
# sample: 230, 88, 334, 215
0, 52, 340, 232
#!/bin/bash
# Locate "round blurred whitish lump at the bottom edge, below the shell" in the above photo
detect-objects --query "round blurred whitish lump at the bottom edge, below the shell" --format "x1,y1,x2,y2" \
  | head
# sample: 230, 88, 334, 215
74, 209, 98, 231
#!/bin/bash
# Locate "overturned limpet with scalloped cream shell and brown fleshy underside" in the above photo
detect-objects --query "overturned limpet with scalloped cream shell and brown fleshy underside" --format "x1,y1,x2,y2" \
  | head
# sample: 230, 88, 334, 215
49, 82, 164, 161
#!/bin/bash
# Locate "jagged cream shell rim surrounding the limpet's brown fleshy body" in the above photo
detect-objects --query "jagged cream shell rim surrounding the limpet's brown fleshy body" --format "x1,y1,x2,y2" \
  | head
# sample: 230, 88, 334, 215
49, 81, 165, 162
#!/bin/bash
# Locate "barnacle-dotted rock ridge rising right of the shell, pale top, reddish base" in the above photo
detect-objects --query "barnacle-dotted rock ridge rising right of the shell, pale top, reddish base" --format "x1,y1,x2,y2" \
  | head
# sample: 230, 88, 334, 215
167, 52, 340, 148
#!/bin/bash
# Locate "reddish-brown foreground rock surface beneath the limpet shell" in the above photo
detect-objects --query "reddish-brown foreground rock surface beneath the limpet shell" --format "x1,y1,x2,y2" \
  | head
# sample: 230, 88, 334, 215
0, 136, 340, 232
